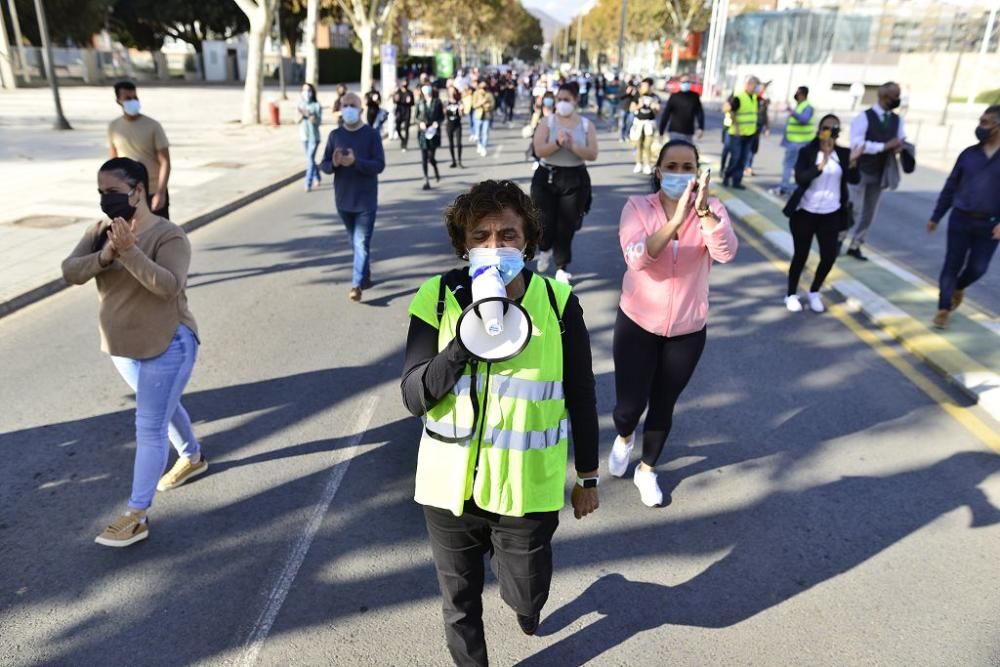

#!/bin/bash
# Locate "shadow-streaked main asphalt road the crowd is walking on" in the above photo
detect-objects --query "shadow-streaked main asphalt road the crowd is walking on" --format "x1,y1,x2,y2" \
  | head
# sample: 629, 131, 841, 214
0, 112, 1000, 666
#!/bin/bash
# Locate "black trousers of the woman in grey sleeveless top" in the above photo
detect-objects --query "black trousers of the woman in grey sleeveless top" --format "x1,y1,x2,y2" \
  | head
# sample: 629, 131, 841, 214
531, 165, 590, 269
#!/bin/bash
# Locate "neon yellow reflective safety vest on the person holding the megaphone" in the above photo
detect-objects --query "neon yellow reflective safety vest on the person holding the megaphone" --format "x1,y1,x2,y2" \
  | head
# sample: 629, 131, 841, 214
414, 276, 570, 516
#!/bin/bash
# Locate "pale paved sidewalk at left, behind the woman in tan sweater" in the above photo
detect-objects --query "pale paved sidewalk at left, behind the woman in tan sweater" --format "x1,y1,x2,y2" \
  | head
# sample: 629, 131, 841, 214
0, 85, 322, 317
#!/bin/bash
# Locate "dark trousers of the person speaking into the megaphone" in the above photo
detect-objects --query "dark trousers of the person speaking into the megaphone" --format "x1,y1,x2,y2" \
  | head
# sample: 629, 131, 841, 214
424, 500, 559, 667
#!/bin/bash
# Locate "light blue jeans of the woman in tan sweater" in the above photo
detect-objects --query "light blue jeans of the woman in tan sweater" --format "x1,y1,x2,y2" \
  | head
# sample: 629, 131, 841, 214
111, 324, 201, 510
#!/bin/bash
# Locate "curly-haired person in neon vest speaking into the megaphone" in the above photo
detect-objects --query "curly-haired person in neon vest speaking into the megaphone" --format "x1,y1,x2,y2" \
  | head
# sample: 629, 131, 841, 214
402, 180, 599, 666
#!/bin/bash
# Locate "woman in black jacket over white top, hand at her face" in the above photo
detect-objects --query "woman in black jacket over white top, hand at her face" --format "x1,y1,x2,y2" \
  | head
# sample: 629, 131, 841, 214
784, 114, 861, 313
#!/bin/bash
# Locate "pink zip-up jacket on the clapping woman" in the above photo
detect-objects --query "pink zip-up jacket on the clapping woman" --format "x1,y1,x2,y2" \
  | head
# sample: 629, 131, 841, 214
618, 193, 739, 337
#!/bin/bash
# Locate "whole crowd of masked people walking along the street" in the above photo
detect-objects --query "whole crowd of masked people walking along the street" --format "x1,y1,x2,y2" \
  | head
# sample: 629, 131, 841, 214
56, 66, 1000, 665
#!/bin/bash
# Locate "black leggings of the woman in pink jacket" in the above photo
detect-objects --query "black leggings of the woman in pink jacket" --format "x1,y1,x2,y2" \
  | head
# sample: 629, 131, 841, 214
612, 308, 706, 467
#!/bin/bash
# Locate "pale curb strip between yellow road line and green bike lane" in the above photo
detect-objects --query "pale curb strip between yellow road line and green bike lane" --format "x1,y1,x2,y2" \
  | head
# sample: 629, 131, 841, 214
716, 185, 1000, 421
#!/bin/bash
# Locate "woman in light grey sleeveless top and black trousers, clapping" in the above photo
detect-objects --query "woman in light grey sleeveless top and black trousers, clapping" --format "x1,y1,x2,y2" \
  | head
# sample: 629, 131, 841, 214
531, 81, 597, 283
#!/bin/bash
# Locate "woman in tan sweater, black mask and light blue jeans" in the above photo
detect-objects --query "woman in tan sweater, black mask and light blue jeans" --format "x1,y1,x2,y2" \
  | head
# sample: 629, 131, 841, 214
62, 158, 208, 547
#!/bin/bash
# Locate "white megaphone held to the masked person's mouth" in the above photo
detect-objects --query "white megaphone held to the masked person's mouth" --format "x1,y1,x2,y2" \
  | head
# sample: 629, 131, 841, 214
457, 266, 531, 362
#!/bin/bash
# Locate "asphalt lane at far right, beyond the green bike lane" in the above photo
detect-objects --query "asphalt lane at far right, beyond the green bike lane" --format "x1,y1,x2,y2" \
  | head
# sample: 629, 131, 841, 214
705, 108, 1000, 319
